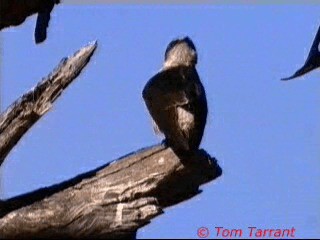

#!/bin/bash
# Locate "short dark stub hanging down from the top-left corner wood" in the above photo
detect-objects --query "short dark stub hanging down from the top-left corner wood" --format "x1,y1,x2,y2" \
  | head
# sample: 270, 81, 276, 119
34, 0, 60, 44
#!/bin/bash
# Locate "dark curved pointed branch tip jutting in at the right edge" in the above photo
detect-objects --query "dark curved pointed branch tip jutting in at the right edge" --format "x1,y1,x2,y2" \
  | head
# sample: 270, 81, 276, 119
281, 26, 320, 81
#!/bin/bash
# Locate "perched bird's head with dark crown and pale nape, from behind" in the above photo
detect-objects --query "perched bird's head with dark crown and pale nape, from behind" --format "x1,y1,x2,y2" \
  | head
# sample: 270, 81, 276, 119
164, 37, 198, 68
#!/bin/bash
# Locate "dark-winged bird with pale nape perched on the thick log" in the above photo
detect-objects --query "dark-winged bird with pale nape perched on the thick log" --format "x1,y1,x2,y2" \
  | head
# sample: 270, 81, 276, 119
142, 36, 208, 153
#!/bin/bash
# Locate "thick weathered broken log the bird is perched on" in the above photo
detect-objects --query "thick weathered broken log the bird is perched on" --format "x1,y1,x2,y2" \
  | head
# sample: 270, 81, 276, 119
0, 145, 221, 239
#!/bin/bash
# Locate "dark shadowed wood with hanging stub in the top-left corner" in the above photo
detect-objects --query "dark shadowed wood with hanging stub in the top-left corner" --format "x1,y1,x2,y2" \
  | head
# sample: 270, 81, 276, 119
0, 0, 60, 43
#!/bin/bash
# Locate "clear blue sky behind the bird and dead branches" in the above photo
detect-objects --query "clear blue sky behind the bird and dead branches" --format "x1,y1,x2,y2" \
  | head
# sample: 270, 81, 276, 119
1, 4, 320, 238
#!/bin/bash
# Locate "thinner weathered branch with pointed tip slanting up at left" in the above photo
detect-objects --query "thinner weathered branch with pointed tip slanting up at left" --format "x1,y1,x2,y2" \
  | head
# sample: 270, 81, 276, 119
0, 42, 97, 166
